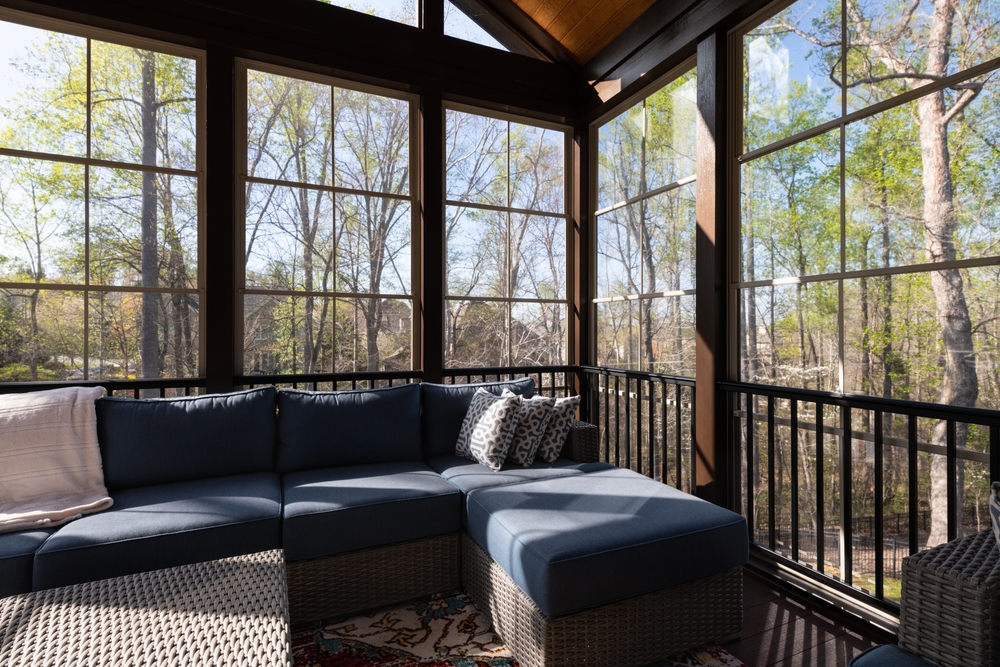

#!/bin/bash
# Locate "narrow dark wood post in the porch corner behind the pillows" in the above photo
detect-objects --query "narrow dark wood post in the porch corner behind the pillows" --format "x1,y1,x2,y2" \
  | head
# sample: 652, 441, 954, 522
567, 124, 593, 394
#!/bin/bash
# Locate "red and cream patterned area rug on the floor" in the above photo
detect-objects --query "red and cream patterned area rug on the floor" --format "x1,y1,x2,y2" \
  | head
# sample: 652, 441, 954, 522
292, 592, 746, 667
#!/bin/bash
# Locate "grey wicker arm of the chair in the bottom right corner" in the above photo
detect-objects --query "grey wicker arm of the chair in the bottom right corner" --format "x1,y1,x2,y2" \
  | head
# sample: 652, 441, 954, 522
899, 530, 1000, 667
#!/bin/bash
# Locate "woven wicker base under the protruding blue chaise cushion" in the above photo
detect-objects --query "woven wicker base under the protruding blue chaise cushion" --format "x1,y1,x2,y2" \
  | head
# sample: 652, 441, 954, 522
462, 535, 743, 667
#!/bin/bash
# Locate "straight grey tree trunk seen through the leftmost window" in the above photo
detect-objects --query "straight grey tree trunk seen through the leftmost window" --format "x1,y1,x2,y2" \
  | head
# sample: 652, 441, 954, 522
140, 51, 160, 378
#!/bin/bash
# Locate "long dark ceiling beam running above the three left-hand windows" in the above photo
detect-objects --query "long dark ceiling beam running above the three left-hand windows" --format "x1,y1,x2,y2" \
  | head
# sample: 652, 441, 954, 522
0, 0, 591, 122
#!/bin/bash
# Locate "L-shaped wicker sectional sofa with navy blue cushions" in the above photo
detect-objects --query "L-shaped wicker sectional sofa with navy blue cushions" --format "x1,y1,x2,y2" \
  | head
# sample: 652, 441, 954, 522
0, 378, 748, 666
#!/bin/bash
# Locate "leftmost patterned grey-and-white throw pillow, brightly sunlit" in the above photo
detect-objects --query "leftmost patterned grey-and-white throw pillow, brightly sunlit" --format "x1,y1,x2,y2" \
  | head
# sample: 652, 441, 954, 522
455, 389, 521, 470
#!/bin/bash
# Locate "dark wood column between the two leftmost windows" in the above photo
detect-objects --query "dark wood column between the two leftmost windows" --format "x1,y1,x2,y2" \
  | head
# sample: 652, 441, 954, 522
198, 44, 236, 393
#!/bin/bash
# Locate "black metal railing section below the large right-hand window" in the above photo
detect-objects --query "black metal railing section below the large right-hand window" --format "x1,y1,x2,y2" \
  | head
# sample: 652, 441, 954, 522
721, 382, 1000, 612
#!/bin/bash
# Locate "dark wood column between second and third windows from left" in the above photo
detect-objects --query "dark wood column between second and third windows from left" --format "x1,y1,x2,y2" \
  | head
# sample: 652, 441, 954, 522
416, 94, 444, 382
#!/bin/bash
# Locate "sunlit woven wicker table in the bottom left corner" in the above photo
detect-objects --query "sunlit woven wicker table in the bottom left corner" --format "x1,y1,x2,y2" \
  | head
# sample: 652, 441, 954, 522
0, 551, 291, 667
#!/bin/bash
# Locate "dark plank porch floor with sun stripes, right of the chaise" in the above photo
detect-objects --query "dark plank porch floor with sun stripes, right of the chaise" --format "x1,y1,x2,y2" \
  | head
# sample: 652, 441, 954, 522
723, 571, 885, 667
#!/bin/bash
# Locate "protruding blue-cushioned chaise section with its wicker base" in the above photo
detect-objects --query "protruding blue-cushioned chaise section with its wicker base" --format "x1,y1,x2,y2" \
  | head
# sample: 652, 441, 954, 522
462, 468, 749, 667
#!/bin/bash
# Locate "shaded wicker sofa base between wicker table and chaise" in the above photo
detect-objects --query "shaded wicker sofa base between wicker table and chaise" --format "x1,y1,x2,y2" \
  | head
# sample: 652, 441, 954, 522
287, 533, 461, 625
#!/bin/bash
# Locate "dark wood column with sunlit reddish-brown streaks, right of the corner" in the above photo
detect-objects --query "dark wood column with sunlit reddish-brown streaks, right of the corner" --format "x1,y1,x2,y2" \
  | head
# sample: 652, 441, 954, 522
695, 31, 731, 507
